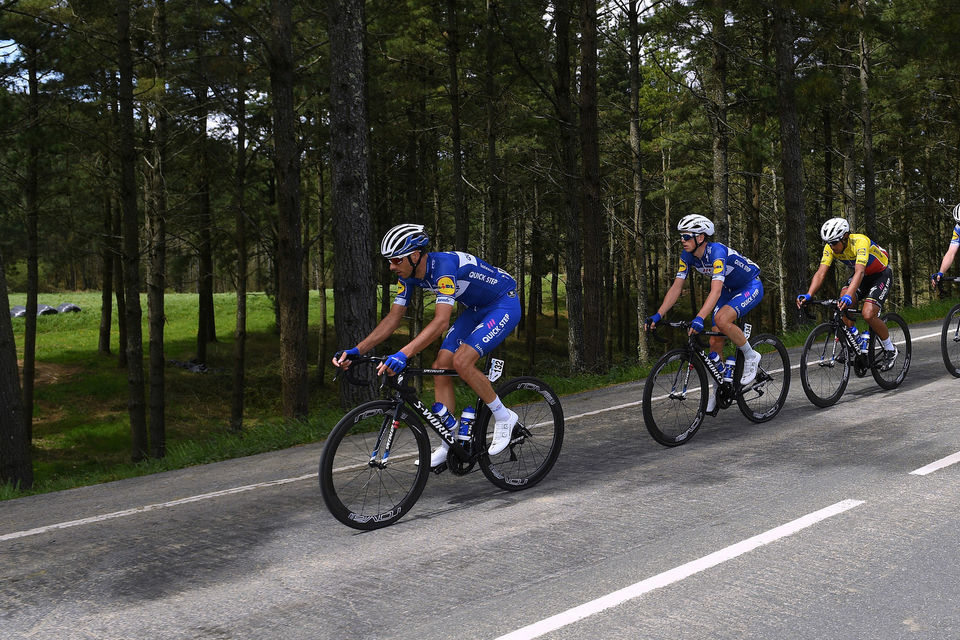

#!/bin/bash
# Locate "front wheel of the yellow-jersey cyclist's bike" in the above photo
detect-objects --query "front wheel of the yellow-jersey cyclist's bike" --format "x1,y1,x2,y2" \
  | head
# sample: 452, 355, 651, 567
800, 322, 855, 408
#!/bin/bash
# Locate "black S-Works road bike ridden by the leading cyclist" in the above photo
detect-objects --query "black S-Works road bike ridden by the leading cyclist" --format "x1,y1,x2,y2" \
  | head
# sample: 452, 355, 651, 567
320, 356, 563, 530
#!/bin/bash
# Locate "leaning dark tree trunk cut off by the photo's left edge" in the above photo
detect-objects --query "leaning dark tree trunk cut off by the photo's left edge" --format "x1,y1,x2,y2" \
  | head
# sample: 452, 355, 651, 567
0, 248, 33, 490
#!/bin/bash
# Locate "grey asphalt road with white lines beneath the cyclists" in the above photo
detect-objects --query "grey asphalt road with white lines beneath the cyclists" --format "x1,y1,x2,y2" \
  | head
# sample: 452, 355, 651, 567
0, 323, 960, 640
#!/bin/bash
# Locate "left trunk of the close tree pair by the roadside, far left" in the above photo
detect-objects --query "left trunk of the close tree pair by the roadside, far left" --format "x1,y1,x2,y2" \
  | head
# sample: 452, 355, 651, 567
116, 0, 148, 462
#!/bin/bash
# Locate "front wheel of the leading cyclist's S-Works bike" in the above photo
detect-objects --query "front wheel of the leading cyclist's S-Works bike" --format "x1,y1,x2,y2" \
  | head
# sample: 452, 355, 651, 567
319, 400, 430, 530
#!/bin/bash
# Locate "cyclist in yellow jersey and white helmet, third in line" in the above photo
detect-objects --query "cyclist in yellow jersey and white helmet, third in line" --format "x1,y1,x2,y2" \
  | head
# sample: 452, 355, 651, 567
797, 218, 897, 371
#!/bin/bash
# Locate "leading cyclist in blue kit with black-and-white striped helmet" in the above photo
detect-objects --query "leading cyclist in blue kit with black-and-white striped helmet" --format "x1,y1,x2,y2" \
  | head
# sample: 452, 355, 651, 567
333, 224, 521, 467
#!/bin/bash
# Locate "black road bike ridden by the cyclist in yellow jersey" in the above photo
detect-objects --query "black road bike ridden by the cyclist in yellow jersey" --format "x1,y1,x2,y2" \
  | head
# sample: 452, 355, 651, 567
800, 300, 911, 407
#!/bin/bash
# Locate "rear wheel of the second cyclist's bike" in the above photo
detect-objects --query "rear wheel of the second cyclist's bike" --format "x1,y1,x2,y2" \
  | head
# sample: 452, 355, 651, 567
736, 333, 790, 423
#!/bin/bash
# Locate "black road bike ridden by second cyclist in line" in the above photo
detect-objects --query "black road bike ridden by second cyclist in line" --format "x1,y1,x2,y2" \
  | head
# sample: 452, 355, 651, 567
643, 321, 790, 447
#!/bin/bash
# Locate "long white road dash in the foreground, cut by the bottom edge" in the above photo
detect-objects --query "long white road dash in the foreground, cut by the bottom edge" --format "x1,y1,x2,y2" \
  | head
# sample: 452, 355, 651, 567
497, 500, 863, 640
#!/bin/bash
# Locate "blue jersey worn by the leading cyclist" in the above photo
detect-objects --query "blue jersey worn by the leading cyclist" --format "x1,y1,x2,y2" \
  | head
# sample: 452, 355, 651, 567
393, 251, 517, 309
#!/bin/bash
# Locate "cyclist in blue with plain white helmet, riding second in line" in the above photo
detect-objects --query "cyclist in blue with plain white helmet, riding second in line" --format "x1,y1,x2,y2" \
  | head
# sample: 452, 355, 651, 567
644, 213, 763, 413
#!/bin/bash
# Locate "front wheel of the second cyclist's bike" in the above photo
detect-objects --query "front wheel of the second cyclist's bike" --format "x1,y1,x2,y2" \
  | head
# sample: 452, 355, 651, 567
643, 349, 710, 447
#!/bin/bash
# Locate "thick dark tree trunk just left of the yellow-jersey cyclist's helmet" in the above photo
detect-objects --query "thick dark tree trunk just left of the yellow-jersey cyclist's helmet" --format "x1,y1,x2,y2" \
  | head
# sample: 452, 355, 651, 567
772, 4, 809, 326
